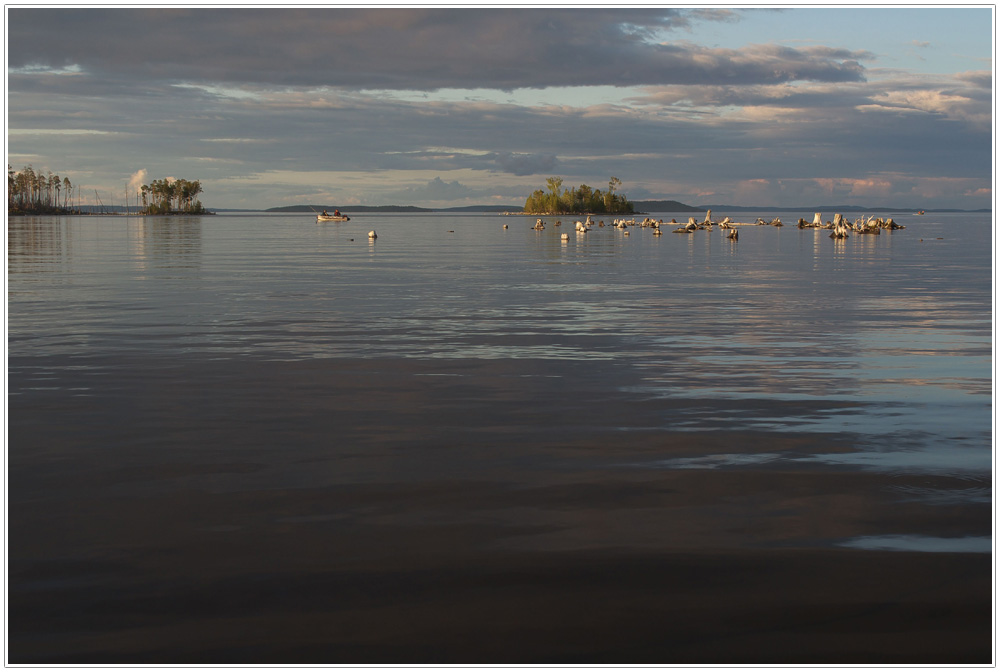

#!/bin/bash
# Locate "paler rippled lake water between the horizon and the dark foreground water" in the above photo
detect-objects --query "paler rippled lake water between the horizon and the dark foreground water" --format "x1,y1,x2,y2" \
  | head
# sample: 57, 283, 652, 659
8, 215, 992, 506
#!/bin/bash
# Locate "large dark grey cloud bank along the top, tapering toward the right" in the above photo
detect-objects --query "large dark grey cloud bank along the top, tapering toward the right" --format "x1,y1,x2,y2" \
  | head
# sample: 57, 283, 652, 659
8, 8, 866, 90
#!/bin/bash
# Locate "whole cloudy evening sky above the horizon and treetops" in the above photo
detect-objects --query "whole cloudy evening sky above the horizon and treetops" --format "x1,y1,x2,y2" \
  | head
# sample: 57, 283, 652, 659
6, 5, 994, 209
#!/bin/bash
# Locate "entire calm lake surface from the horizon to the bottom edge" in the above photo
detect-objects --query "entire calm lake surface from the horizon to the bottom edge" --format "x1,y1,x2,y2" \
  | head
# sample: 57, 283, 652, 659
6, 213, 994, 663
